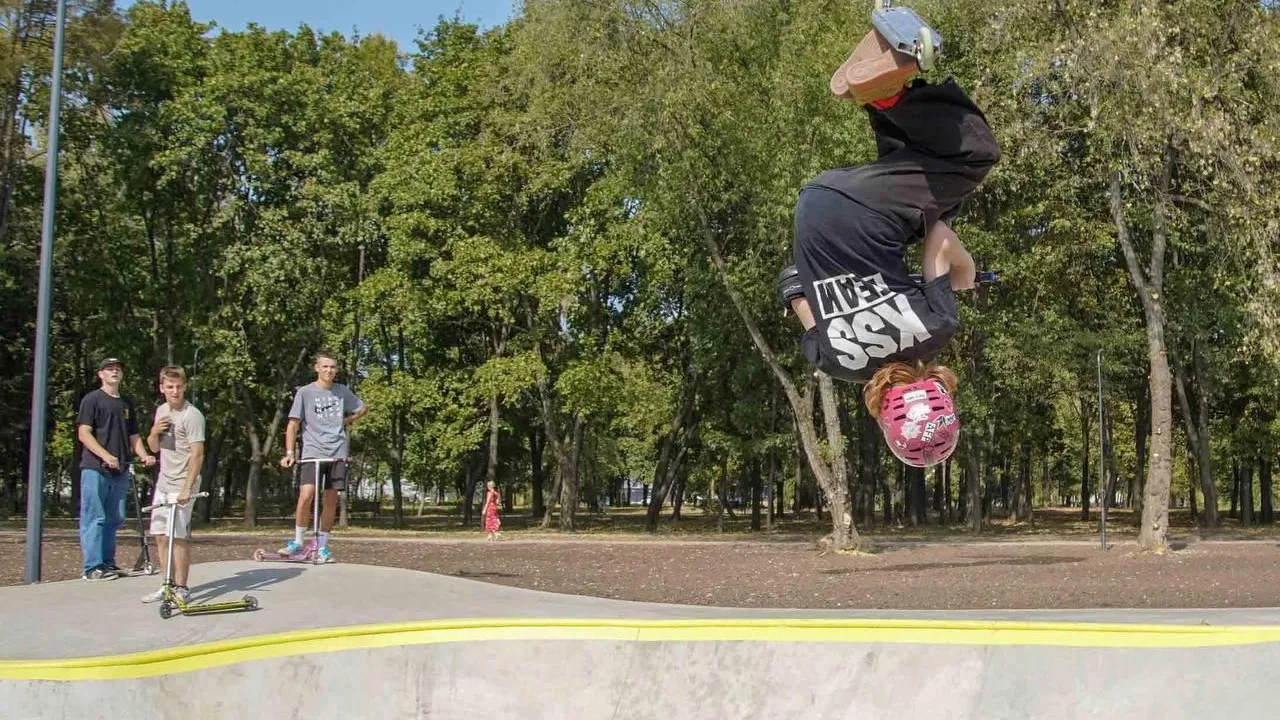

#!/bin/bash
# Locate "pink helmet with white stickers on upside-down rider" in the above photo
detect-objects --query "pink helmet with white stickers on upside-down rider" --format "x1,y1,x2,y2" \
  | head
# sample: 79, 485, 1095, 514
879, 380, 960, 468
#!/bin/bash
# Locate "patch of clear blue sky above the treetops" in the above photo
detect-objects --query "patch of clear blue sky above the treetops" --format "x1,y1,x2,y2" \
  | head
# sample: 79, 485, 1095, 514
116, 0, 518, 50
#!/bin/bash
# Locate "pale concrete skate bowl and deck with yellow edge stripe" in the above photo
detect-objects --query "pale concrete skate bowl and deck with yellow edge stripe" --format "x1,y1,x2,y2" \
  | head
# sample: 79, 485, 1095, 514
0, 561, 1280, 720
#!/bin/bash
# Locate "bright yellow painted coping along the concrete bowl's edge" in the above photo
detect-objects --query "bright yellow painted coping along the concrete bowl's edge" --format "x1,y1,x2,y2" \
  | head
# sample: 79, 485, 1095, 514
0, 618, 1280, 680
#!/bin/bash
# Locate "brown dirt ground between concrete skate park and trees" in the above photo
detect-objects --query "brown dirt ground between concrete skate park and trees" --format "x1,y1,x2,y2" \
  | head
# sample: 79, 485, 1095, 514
10, 532, 1280, 610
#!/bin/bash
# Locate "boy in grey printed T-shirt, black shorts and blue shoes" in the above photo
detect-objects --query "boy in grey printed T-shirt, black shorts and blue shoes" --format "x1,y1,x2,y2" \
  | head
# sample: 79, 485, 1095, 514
280, 352, 369, 562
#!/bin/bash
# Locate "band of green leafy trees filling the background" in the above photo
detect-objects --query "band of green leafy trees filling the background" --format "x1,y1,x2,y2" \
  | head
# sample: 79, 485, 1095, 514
10, 0, 1280, 550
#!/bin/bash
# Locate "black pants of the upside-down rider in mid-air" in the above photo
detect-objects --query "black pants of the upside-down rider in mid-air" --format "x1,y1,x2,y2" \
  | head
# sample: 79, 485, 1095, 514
809, 79, 1000, 243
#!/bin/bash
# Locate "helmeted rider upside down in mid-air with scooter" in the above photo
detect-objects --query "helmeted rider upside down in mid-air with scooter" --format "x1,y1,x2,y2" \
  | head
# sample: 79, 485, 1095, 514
778, 9, 1000, 468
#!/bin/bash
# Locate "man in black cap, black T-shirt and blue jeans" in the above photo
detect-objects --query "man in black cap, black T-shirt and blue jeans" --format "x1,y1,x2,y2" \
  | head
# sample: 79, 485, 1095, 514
76, 357, 156, 580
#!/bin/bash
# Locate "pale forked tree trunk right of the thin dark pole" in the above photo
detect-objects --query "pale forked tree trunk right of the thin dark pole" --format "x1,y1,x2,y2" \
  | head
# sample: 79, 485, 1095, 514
1111, 163, 1174, 552
